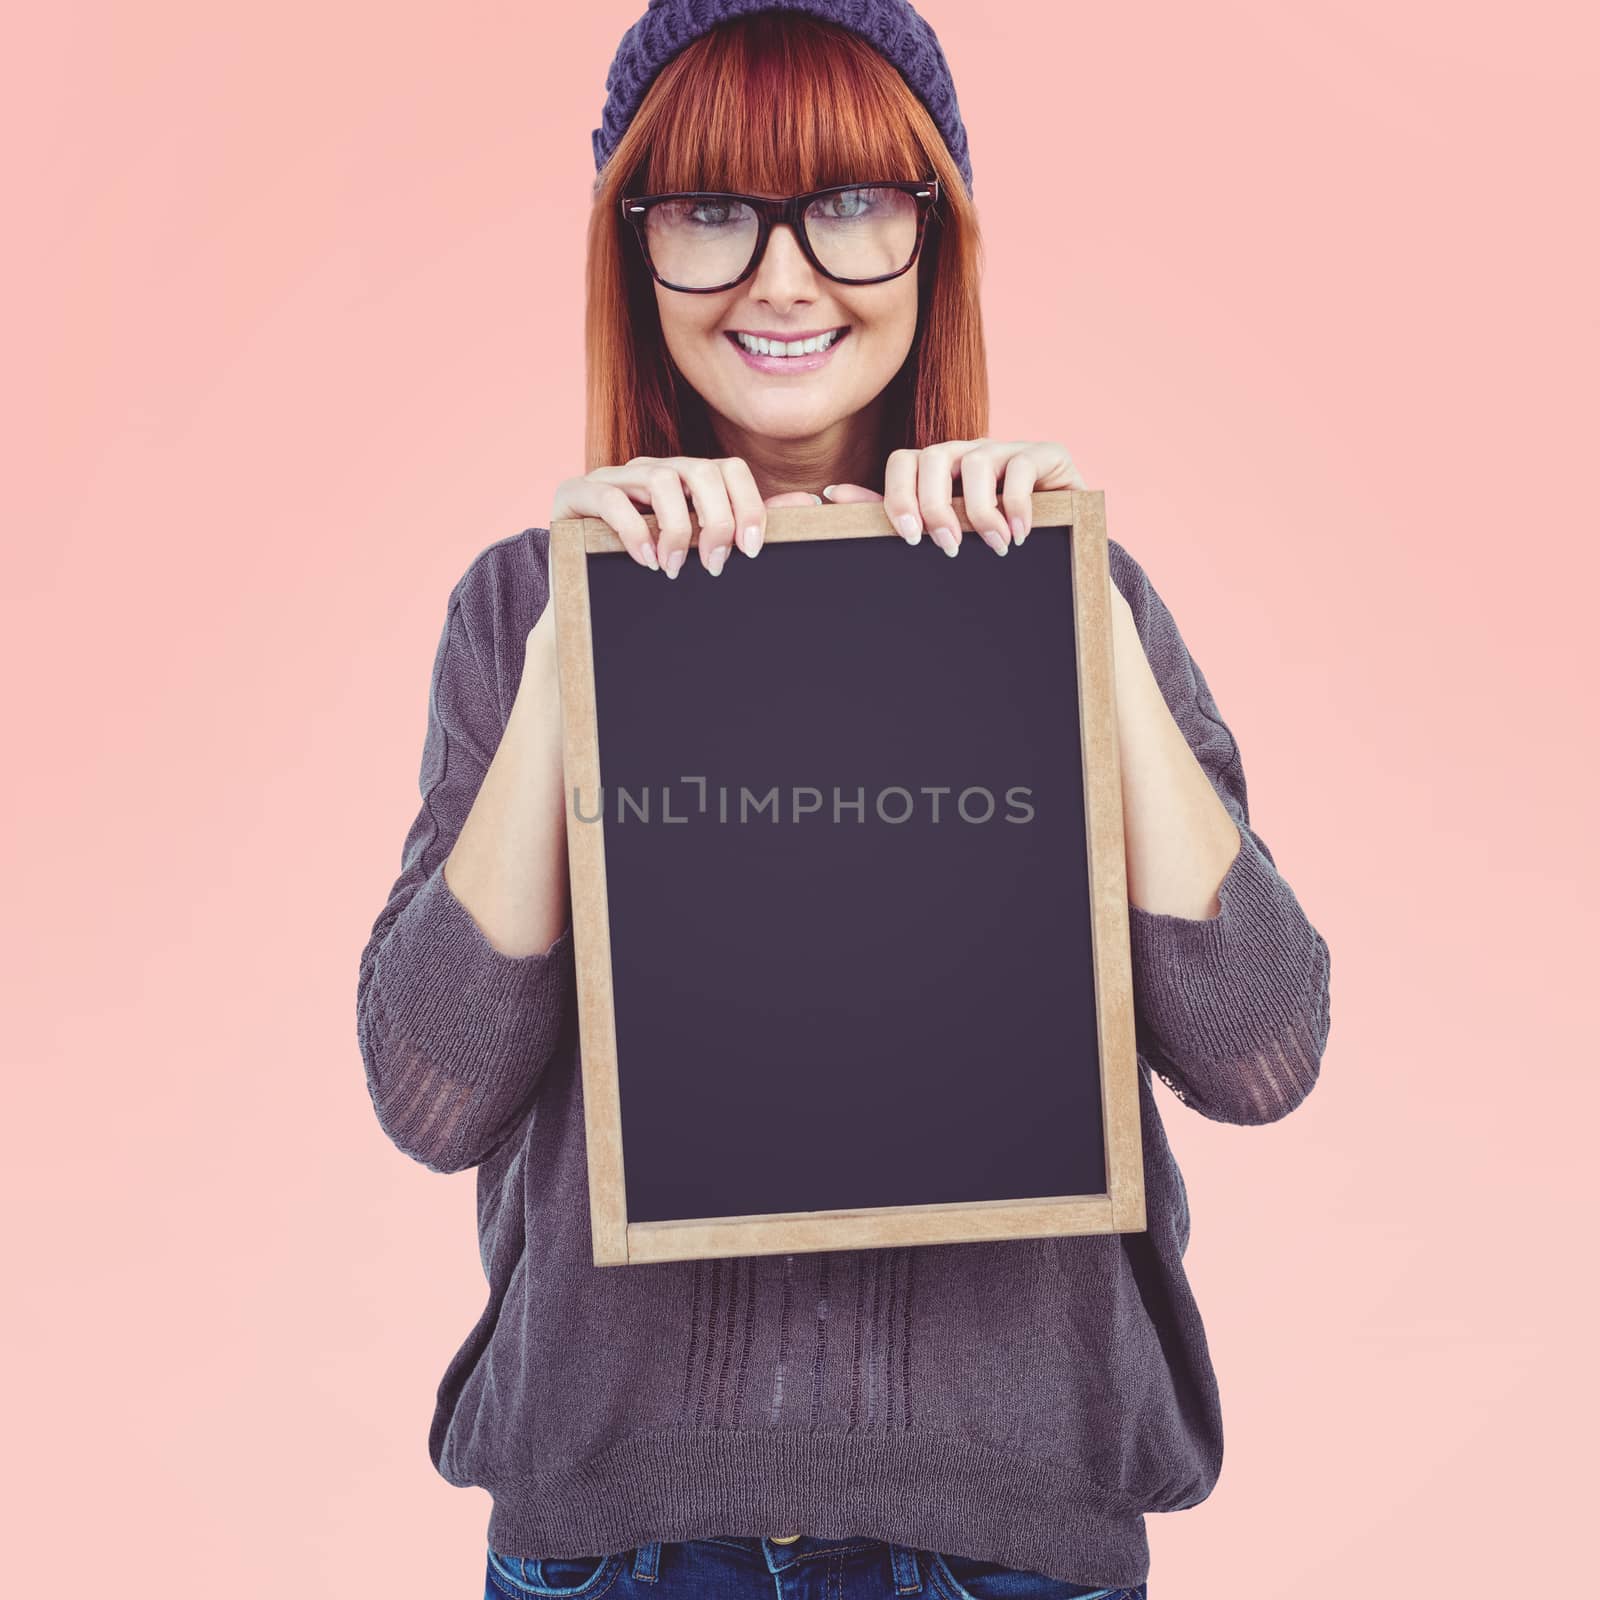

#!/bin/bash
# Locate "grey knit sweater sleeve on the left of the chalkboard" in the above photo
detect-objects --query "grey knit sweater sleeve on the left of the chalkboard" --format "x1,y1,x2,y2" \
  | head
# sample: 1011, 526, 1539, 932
357, 557, 573, 1173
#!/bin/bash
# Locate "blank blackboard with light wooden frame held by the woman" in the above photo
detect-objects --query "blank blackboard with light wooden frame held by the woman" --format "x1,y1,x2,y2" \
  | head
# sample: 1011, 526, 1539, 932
550, 491, 1144, 1266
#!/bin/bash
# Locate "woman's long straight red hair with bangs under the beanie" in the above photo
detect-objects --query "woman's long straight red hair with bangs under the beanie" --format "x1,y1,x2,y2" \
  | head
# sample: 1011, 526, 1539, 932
586, 11, 989, 490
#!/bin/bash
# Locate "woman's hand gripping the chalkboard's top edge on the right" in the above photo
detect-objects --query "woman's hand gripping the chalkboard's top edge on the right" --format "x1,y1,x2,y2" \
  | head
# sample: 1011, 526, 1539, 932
822, 438, 1088, 555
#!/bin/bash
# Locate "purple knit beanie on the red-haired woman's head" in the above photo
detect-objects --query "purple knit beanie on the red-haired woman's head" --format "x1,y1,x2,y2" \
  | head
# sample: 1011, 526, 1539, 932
592, 0, 973, 194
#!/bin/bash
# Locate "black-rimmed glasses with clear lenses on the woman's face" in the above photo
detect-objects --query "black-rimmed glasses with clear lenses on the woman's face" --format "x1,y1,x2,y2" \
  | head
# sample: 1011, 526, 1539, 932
621, 178, 939, 294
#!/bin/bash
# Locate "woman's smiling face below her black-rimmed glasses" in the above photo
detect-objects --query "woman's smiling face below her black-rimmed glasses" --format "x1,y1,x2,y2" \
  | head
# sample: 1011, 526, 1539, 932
656, 208, 918, 446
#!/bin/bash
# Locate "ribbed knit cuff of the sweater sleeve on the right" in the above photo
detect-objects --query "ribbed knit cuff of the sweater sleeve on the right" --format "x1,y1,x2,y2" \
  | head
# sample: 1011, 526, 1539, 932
1128, 829, 1320, 1066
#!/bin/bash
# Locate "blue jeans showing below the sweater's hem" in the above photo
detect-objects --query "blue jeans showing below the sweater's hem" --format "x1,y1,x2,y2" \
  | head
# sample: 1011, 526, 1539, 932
483, 1534, 1147, 1600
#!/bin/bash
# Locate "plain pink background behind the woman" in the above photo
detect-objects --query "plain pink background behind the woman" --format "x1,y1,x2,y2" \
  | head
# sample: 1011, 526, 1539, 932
9, 0, 1600, 1600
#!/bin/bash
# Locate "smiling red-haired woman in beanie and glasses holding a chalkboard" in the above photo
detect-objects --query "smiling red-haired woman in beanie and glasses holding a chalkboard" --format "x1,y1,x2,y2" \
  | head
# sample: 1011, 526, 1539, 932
358, 0, 1328, 1600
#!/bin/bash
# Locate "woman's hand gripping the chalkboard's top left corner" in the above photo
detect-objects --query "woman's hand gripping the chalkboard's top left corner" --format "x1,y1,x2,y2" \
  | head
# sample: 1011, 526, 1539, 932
550, 456, 821, 578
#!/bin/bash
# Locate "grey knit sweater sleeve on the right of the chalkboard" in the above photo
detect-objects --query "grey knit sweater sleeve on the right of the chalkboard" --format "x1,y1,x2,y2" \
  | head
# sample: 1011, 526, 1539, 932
1112, 542, 1330, 1123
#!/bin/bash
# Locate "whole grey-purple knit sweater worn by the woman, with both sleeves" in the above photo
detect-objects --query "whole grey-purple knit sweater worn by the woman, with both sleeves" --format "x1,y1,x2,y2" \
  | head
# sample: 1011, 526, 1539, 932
357, 528, 1328, 1586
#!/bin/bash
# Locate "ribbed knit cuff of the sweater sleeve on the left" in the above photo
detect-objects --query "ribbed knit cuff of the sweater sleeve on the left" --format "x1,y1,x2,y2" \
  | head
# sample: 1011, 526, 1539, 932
374, 862, 573, 1083
